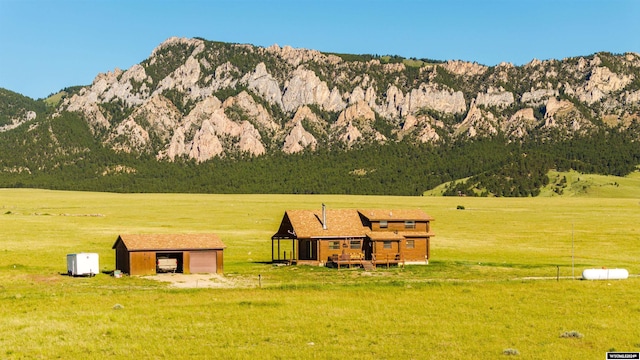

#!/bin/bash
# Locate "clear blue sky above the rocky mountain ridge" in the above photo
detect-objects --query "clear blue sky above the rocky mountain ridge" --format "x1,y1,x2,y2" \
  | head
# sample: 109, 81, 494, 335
0, 0, 640, 99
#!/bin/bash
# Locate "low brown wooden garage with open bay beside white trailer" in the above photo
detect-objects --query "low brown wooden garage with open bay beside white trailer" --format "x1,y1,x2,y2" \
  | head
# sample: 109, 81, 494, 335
112, 234, 225, 275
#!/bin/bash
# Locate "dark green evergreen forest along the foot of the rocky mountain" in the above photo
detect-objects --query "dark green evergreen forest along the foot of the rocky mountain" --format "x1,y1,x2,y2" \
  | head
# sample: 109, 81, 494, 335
0, 112, 640, 197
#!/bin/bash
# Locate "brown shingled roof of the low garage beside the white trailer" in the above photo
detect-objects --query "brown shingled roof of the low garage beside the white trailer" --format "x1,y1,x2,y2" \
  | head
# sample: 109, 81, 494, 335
112, 234, 226, 251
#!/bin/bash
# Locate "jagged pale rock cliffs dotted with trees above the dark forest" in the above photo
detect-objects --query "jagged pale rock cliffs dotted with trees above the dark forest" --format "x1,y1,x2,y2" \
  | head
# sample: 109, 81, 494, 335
52, 38, 640, 162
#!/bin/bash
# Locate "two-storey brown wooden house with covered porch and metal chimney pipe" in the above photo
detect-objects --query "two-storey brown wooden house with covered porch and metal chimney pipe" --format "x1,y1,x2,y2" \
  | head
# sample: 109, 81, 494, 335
271, 205, 434, 268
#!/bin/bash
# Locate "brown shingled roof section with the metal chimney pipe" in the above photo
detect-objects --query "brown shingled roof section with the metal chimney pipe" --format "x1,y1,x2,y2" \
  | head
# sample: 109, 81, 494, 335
285, 209, 368, 239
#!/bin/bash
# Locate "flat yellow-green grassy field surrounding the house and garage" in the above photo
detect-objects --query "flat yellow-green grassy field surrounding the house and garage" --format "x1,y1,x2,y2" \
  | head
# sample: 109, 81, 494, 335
0, 190, 640, 359
